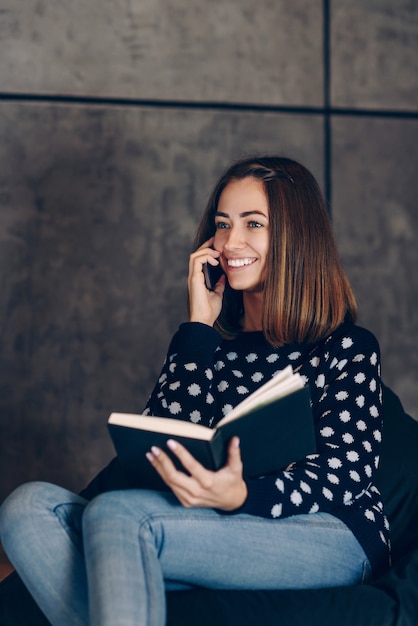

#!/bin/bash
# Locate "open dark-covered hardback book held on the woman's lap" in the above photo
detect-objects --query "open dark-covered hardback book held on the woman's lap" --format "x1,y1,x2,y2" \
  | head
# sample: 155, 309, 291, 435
108, 365, 316, 489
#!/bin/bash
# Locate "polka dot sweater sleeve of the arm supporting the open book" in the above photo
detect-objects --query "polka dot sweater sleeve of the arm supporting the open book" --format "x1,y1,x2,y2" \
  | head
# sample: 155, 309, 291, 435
240, 328, 382, 518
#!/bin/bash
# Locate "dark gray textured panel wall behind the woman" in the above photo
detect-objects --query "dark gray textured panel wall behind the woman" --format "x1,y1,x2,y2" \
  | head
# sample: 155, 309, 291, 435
0, 0, 418, 501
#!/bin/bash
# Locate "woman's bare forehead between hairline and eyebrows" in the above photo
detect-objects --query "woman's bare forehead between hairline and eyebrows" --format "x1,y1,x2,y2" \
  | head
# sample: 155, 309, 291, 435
217, 177, 269, 215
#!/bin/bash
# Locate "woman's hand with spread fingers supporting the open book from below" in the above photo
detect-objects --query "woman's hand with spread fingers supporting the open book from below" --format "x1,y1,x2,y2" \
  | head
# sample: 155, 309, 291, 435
147, 437, 248, 511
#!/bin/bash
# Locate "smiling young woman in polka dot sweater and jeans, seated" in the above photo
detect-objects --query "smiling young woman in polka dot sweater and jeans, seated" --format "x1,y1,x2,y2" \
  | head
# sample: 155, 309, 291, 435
0, 157, 389, 626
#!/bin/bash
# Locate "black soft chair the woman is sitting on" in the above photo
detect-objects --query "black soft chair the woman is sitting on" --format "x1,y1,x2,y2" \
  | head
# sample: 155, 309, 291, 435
0, 388, 418, 626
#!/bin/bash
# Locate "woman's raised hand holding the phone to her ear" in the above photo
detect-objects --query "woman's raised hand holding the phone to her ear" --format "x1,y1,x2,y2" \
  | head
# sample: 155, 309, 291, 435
188, 237, 226, 326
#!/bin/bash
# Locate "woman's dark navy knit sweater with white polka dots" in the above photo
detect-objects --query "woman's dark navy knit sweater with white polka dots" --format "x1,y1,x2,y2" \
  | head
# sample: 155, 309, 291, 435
145, 323, 390, 572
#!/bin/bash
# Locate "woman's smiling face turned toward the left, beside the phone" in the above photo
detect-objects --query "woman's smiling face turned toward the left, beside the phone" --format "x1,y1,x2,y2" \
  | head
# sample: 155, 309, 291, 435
214, 176, 270, 292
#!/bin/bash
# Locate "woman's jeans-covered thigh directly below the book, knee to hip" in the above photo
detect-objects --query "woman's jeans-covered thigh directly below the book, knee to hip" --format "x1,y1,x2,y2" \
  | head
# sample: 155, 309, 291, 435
87, 490, 368, 589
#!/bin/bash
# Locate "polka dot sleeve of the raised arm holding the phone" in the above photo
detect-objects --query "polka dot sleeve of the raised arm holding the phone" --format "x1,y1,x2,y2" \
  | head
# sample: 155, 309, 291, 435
144, 322, 222, 426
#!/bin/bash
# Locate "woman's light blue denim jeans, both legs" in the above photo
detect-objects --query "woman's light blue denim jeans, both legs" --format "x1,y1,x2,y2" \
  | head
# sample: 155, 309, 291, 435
0, 483, 370, 626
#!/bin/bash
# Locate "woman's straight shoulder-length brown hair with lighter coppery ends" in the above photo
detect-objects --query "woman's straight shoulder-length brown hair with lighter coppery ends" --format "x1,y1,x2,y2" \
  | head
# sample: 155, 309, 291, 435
194, 156, 357, 346
